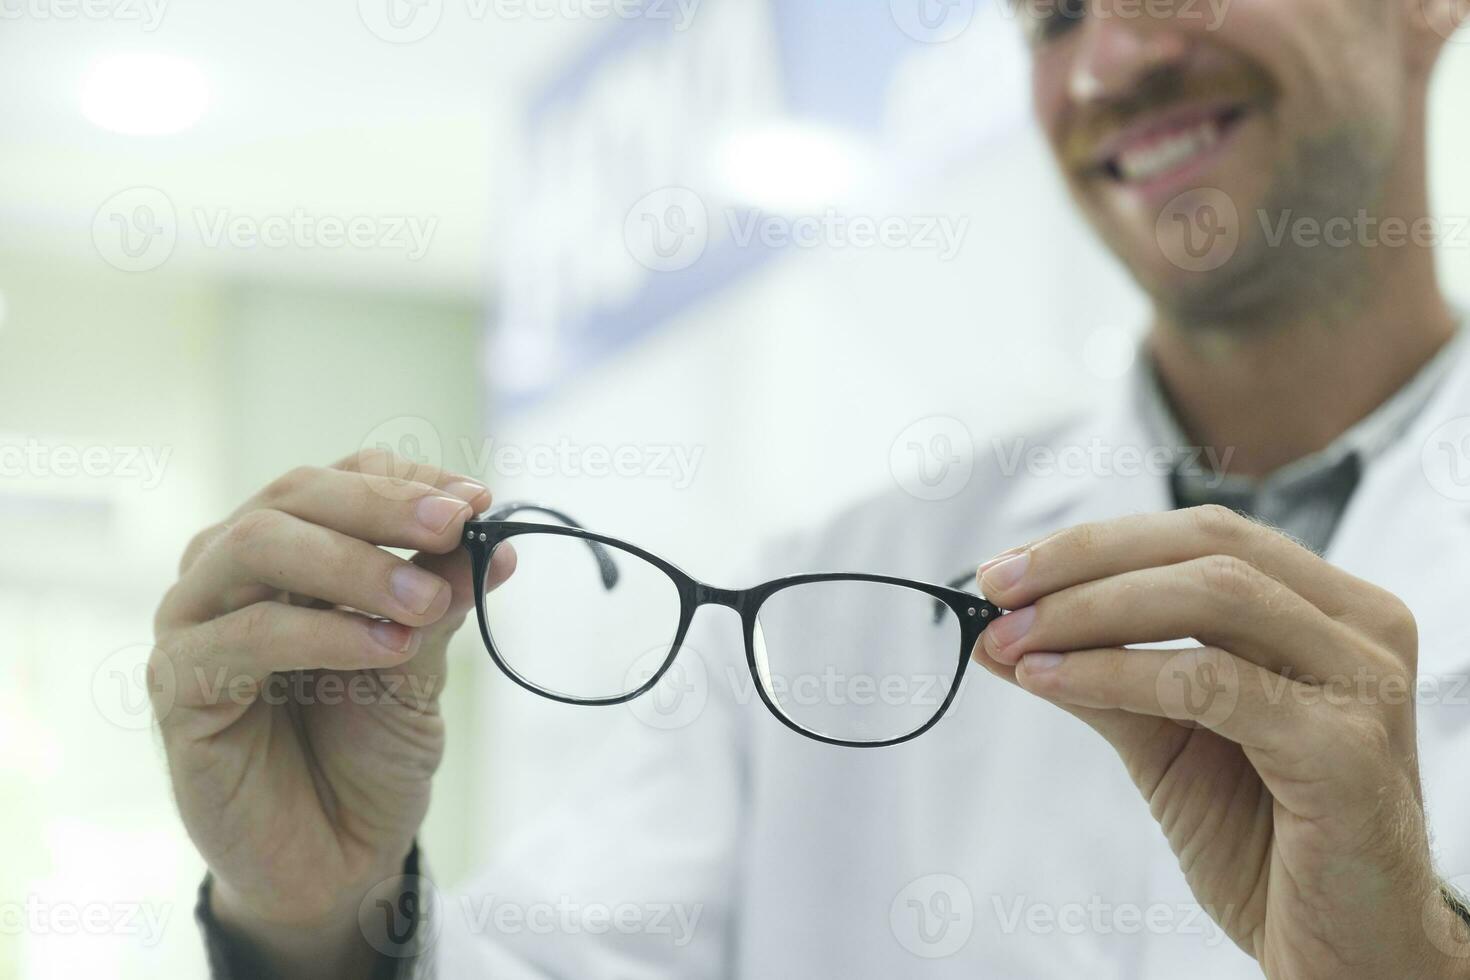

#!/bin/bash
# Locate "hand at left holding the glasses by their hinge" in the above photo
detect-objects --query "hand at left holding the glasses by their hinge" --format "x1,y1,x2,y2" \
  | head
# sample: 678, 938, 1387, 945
150, 453, 515, 977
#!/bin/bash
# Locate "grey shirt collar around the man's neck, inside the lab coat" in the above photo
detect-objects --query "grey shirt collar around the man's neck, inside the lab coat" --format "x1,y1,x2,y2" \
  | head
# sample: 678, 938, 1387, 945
1133, 318, 1467, 492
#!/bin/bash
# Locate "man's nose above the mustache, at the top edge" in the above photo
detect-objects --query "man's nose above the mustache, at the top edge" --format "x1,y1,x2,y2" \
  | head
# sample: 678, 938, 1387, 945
1067, 8, 1189, 104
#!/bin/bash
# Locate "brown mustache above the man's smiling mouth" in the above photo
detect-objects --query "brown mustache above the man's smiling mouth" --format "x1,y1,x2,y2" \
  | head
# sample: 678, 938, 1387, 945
1061, 66, 1276, 169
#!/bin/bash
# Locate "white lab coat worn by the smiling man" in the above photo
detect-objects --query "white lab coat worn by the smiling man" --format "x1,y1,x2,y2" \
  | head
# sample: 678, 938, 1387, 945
428, 346, 1470, 980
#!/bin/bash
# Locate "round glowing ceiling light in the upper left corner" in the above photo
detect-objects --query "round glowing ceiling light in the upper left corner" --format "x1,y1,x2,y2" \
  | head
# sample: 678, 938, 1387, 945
81, 53, 209, 137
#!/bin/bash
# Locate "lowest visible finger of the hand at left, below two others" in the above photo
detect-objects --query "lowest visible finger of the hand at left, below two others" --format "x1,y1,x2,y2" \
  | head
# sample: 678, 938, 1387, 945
160, 601, 422, 707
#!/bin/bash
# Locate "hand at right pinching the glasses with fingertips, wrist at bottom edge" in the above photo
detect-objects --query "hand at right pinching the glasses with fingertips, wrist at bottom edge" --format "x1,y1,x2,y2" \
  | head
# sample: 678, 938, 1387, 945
975, 507, 1470, 980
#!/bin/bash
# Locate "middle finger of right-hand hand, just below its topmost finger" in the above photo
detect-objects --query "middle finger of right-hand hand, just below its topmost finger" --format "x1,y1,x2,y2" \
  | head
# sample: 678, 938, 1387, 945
982, 555, 1364, 677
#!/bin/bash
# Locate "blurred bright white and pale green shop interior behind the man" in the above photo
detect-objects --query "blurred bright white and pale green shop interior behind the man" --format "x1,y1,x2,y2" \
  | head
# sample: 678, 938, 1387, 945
0, 0, 1470, 980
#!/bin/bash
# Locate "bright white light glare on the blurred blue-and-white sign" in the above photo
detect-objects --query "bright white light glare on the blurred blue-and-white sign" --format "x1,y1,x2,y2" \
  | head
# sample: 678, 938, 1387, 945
716, 123, 867, 210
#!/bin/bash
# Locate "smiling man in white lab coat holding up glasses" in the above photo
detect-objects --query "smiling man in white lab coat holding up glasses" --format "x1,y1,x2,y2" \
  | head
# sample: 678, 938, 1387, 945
154, 0, 1470, 980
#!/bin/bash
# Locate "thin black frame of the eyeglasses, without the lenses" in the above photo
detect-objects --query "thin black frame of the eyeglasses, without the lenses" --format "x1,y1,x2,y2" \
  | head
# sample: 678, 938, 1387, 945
465, 504, 1001, 748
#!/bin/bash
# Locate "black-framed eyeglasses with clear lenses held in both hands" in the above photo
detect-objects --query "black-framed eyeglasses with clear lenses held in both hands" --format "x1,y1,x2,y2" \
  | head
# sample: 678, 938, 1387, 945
465, 502, 1001, 746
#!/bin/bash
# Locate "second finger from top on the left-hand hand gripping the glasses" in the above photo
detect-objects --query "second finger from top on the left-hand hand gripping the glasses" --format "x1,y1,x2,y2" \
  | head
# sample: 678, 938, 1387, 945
171, 510, 451, 626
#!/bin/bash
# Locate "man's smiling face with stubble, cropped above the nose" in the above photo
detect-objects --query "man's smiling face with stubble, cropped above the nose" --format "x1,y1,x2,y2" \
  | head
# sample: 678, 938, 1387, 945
1017, 0, 1410, 314
